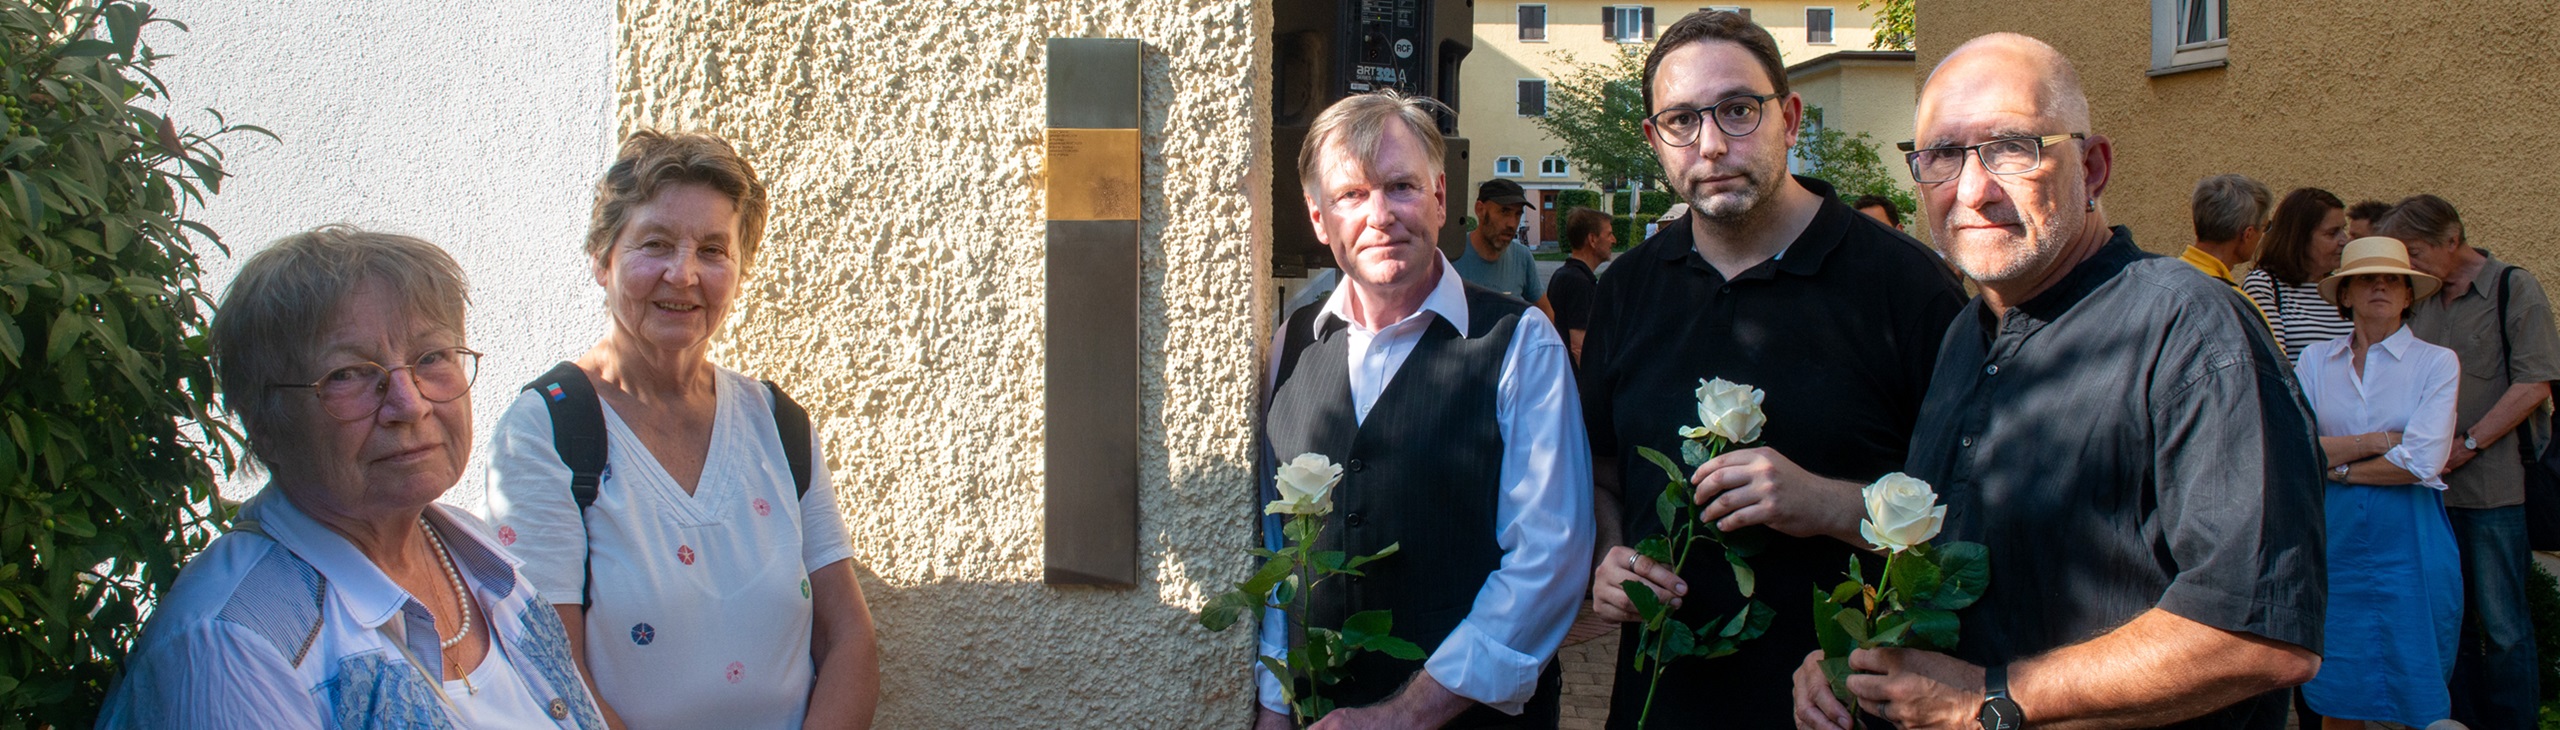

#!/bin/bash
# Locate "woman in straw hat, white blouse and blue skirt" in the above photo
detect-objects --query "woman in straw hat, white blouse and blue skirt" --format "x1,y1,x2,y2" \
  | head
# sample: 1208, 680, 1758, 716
2294, 238, 2463, 727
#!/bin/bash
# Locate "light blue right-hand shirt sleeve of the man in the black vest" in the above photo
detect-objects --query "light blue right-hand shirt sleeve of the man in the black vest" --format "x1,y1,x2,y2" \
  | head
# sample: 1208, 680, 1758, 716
1423, 310, 1592, 715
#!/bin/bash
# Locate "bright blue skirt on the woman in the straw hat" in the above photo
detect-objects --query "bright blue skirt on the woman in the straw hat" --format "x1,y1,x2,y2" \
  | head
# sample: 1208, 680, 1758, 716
2301, 482, 2463, 727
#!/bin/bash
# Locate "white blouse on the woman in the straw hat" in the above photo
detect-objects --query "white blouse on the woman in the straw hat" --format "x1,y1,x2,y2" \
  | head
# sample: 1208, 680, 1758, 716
2294, 325, 2463, 489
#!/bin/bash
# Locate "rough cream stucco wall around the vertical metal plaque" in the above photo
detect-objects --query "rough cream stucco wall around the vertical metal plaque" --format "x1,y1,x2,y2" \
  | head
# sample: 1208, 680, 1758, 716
614, 0, 1270, 727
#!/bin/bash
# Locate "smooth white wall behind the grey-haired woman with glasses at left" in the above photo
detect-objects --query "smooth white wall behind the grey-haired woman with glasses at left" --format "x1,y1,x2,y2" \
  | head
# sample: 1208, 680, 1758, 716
143, 0, 614, 507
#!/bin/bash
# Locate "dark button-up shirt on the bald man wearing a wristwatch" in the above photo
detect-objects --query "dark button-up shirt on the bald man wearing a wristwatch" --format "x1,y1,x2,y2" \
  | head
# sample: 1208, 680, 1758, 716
1910, 228, 2327, 727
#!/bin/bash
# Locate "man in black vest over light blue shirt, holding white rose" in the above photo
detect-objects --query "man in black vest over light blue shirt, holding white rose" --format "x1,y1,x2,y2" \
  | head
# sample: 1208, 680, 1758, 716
1254, 92, 1592, 727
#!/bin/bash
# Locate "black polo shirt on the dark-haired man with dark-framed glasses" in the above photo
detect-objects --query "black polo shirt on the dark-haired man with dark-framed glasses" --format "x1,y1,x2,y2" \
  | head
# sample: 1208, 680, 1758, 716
1582, 177, 1964, 727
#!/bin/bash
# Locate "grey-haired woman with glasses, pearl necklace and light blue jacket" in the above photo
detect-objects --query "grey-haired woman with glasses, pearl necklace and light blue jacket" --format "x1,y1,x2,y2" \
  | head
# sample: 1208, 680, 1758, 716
100, 225, 604, 730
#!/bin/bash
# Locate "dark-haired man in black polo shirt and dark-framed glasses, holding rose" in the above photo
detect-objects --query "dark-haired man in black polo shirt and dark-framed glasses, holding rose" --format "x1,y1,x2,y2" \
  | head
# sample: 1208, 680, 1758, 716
1582, 13, 1964, 727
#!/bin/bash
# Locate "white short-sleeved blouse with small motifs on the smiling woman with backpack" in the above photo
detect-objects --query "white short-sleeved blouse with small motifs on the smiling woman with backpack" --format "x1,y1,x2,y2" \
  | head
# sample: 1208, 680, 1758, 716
486, 369, 852, 730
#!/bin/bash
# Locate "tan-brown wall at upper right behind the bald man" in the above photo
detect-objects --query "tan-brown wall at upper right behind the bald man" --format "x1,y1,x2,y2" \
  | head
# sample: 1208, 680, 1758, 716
1917, 0, 2560, 279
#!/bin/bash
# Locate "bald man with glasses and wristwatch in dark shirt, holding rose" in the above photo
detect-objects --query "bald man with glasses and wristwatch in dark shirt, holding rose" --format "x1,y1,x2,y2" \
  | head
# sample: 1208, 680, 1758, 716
1795, 33, 2327, 730
